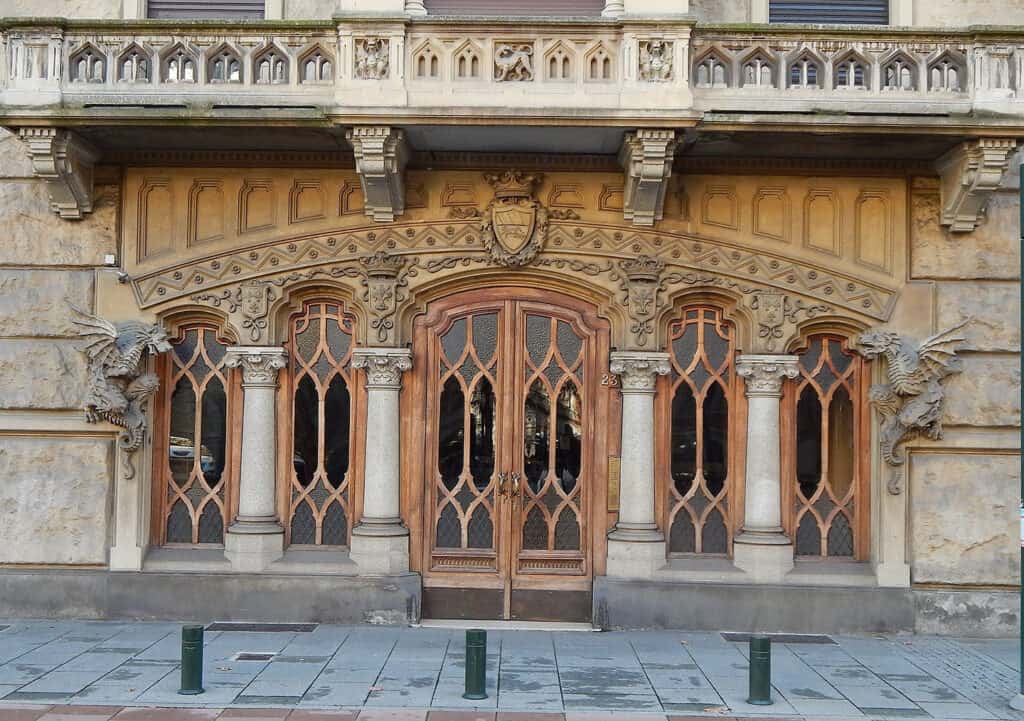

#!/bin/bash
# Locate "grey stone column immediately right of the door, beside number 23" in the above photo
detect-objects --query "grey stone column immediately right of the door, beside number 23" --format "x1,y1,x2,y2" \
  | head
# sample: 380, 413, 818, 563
607, 350, 672, 578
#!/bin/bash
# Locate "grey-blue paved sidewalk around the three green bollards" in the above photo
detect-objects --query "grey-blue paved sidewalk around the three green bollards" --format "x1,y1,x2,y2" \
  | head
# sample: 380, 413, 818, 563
0, 621, 1024, 721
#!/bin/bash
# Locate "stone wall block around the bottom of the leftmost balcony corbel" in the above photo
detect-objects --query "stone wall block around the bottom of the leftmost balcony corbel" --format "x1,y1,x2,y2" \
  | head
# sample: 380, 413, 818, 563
0, 180, 119, 266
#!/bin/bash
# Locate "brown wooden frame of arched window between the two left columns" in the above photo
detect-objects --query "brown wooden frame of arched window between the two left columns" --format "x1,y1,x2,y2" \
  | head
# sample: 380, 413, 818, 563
278, 293, 366, 550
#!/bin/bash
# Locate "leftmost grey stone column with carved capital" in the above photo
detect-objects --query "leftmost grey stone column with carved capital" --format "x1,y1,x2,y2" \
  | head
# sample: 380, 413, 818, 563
224, 346, 288, 572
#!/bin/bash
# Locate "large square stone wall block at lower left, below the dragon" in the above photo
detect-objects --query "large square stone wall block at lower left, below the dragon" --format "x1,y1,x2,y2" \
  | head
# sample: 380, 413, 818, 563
0, 436, 113, 564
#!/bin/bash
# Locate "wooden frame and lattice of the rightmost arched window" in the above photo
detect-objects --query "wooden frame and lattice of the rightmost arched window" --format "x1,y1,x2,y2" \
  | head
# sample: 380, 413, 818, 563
781, 331, 871, 561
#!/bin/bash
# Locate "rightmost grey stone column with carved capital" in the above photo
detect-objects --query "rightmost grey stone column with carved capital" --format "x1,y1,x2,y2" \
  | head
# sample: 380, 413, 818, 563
733, 355, 800, 583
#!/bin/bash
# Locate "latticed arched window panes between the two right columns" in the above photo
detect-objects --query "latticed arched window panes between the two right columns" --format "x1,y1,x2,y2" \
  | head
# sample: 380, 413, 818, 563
664, 306, 735, 555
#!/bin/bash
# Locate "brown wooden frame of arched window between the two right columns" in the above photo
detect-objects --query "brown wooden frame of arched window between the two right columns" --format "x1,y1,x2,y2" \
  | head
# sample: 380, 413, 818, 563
654, 302, 746, 558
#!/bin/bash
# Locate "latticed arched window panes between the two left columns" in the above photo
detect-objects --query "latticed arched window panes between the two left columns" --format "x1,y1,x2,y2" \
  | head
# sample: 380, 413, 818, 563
285, 300, 355, 546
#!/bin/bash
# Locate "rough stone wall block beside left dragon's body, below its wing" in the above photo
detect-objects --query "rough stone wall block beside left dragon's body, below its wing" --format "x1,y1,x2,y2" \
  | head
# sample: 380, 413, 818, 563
0, 339, 87, 407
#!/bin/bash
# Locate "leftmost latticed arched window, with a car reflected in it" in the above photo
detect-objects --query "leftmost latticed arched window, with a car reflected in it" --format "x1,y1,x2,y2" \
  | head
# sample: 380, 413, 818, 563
154, 325, 234, 544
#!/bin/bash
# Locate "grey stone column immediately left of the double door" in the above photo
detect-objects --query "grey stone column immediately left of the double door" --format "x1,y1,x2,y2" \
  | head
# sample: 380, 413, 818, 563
351, 348, 413, 576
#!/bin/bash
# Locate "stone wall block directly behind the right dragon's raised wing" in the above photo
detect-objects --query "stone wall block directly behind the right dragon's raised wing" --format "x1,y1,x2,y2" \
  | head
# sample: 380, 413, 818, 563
936, 282, 1021, 353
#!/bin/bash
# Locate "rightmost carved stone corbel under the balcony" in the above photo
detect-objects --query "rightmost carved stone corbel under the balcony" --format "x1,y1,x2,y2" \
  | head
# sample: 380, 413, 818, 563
936, 137, 1017, 232
